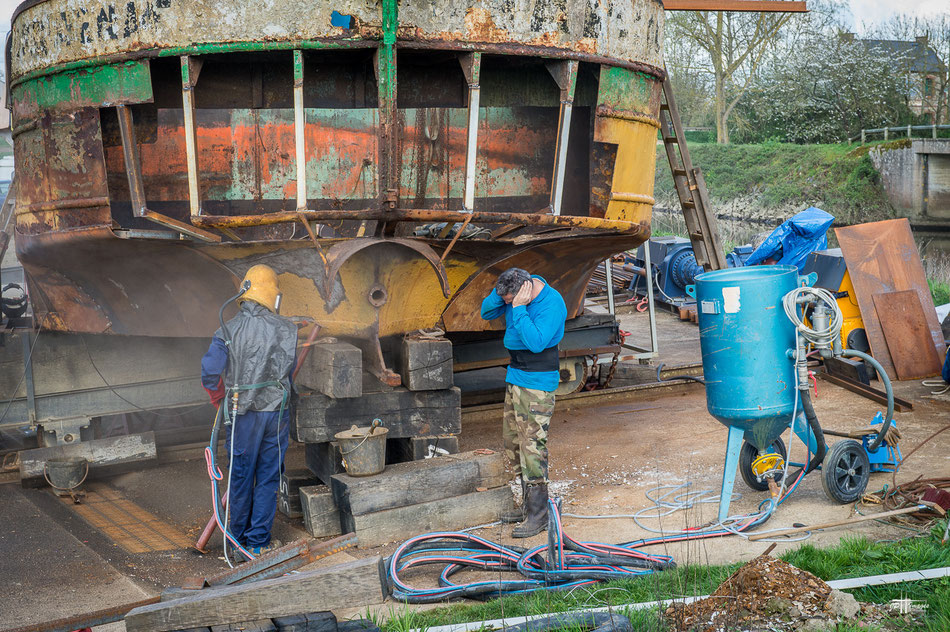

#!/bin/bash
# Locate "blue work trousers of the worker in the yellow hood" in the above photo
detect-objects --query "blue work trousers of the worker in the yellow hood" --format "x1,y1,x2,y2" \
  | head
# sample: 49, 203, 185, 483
225, 410, 290, 548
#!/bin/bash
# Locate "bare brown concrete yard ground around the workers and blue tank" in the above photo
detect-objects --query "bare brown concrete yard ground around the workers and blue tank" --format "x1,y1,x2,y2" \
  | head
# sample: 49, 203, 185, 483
0, 306, 950, 629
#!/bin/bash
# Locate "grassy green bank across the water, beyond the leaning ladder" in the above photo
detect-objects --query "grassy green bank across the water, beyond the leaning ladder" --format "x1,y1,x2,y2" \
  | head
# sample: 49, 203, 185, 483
656, 142, 893, 224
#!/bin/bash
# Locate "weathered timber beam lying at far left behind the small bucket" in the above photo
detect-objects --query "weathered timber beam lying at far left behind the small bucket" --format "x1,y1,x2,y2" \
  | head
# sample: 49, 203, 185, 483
20, 431, 156, 481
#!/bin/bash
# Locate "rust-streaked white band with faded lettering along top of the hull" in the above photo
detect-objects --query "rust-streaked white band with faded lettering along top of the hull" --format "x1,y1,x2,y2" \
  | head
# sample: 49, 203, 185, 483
10, 0, 663, 81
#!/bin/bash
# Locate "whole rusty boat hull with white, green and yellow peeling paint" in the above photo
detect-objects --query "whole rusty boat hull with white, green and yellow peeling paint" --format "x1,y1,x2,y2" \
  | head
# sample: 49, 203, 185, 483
8, 0, 663, 349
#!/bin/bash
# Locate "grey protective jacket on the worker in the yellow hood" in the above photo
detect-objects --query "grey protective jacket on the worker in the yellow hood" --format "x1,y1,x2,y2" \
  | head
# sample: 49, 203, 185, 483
214, 301, 297, 414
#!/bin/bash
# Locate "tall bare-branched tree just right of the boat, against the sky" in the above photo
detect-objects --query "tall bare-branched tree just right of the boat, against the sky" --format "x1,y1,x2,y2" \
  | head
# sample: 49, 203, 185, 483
666, 11, 792, 143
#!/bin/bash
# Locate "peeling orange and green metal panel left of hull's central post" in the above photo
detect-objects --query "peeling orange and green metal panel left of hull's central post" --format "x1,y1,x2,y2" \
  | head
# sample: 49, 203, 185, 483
106, 108, 377, 210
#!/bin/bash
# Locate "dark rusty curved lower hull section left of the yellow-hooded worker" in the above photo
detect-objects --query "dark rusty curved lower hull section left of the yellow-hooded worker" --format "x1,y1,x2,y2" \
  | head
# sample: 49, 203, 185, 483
16, 227, 240, 337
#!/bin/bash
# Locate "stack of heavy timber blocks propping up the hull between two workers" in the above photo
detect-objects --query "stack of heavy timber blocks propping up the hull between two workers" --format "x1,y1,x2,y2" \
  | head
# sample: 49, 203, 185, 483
282, 332, 511, 547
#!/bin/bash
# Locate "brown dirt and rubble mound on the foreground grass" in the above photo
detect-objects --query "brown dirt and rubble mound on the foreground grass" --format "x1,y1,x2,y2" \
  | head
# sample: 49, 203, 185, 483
666, 555, 861, 632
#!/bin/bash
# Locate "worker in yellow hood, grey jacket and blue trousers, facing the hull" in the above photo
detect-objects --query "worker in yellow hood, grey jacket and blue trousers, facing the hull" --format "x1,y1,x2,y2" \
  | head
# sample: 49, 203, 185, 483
201, 265, 297, 555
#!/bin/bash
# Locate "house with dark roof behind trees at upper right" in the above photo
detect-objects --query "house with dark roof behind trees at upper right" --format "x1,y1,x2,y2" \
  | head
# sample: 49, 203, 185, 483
845, 33, 950, 123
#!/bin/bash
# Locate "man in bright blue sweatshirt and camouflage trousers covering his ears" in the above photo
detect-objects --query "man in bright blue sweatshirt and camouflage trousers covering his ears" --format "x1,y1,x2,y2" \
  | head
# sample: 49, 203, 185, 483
482, 268, 567, 538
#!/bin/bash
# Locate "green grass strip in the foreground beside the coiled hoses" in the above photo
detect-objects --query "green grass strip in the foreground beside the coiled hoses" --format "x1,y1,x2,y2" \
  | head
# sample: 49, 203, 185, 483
383, 521, 950, 632
